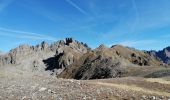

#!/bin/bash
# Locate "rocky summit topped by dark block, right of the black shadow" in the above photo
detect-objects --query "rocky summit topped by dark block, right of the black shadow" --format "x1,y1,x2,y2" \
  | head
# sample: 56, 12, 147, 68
47, 38, 90, 71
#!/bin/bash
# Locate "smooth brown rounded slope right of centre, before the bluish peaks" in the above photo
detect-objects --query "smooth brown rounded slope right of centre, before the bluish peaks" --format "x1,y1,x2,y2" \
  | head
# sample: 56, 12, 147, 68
111, 45, 162, 66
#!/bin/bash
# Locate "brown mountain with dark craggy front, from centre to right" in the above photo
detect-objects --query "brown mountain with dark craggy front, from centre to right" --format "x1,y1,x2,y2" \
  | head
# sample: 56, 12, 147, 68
58, 45, 163, 79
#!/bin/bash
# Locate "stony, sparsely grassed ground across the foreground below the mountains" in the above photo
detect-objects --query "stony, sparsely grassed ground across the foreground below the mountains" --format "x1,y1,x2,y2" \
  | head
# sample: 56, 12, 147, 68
0, 72, 170, 100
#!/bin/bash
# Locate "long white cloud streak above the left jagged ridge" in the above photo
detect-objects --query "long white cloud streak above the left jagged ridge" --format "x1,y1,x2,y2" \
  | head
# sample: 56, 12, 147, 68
0, 27, 56, 41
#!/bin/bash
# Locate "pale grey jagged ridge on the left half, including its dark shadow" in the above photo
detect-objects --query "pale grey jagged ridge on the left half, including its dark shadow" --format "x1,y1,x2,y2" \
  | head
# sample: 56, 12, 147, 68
0, 38, 89, 76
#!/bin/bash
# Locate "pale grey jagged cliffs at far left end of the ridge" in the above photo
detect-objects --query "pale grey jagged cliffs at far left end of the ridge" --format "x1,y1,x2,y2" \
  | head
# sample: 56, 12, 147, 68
0, 42, 48, 66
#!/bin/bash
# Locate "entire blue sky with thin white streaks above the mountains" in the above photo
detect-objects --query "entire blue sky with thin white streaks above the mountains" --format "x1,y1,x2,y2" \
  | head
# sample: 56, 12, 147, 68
0, 0, 170, 51
